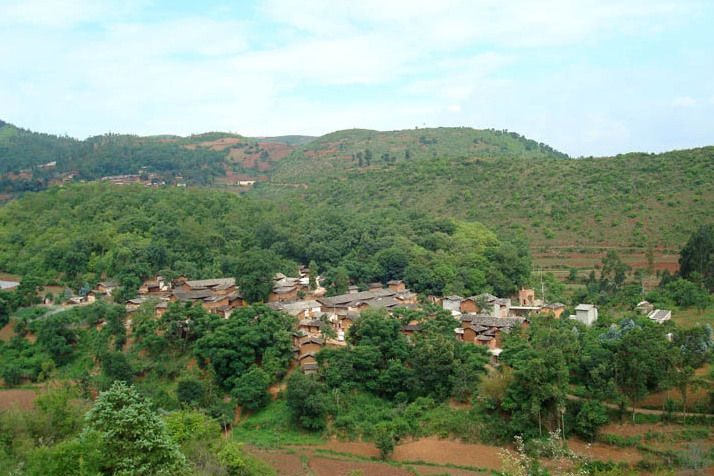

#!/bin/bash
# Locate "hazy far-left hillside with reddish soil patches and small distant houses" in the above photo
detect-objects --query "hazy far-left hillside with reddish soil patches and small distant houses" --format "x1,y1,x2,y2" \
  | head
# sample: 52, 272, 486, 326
0, 121, 311, 193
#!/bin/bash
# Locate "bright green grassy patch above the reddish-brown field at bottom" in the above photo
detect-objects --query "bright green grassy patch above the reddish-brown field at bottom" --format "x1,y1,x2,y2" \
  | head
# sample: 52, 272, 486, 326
233, 399, 326, 448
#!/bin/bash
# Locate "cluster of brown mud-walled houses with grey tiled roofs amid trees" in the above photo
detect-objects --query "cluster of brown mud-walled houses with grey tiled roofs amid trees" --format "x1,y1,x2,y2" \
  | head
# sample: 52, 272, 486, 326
37, 266, 672, 374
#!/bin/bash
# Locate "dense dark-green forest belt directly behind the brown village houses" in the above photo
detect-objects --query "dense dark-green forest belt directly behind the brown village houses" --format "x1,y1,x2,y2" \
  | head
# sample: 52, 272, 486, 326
0, 184, 530, 295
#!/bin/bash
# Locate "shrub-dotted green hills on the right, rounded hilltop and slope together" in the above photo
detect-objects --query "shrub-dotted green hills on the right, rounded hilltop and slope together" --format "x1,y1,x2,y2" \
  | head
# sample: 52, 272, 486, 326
254, 128, 714, 250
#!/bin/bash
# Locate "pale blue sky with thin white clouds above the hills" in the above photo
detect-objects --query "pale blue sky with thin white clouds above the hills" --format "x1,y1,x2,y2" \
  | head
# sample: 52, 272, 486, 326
0, 0, 714, 156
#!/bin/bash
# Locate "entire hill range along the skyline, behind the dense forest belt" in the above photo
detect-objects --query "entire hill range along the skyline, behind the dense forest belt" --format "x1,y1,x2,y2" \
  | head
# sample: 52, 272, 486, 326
0, 122, 714, 258
